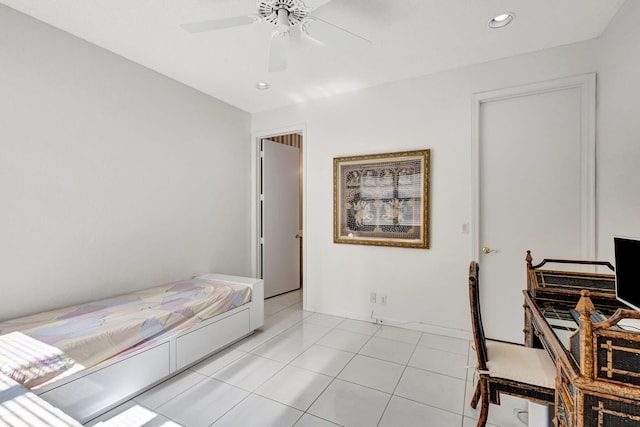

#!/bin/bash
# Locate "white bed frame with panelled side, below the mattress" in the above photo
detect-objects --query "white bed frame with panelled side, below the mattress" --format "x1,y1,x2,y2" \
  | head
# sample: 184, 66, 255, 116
33, 274, 264, 423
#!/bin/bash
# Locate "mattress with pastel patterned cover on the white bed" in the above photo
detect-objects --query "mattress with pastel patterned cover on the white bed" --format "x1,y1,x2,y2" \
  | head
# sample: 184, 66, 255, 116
0, 278, 251, 387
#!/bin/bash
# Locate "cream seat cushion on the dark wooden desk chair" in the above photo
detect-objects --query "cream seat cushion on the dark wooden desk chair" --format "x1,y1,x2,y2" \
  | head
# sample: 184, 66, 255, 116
486, 340, 556, 388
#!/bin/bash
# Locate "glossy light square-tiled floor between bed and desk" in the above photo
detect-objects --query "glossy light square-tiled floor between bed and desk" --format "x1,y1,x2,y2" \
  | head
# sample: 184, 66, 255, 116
88, 291, 527, 427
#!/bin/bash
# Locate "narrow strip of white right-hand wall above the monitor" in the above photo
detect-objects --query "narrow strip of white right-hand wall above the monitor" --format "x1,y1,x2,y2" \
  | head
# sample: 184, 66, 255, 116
597, 1, 640, 260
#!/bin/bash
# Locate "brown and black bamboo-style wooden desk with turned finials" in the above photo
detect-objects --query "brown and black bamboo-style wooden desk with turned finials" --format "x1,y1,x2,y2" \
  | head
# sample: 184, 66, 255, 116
524, 254, 640, 427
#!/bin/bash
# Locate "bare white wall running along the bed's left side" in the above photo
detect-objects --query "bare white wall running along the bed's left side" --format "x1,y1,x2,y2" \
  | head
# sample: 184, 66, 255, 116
0, 6, 251, 319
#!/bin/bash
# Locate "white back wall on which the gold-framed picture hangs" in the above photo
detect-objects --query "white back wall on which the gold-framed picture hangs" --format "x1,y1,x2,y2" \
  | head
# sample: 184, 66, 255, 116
252, 42, 596, 335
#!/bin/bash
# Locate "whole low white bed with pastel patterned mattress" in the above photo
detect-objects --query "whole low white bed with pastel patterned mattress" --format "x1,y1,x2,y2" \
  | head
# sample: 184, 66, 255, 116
0, 274, 264, 423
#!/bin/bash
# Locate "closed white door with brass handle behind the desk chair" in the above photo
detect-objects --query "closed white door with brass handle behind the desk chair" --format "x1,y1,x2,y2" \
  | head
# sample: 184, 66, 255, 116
475, 76, 595, 343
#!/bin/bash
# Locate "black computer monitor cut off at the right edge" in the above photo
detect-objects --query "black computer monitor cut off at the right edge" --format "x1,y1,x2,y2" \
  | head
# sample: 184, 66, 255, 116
613, 236, 640, 311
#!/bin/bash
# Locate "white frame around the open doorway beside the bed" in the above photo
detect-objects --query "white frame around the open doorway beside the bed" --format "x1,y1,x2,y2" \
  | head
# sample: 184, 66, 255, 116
251, 123, 307, 304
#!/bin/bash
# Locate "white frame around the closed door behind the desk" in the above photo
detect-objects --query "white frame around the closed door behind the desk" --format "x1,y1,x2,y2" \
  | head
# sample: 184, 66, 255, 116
471, 73, 596, 260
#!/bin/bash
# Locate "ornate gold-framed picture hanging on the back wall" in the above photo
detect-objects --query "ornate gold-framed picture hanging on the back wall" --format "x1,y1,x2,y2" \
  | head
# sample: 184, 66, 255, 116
333, 150, 430, 249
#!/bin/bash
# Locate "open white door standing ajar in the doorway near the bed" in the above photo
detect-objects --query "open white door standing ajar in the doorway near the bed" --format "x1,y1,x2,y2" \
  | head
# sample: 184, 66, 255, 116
261, 140, 300, 297
